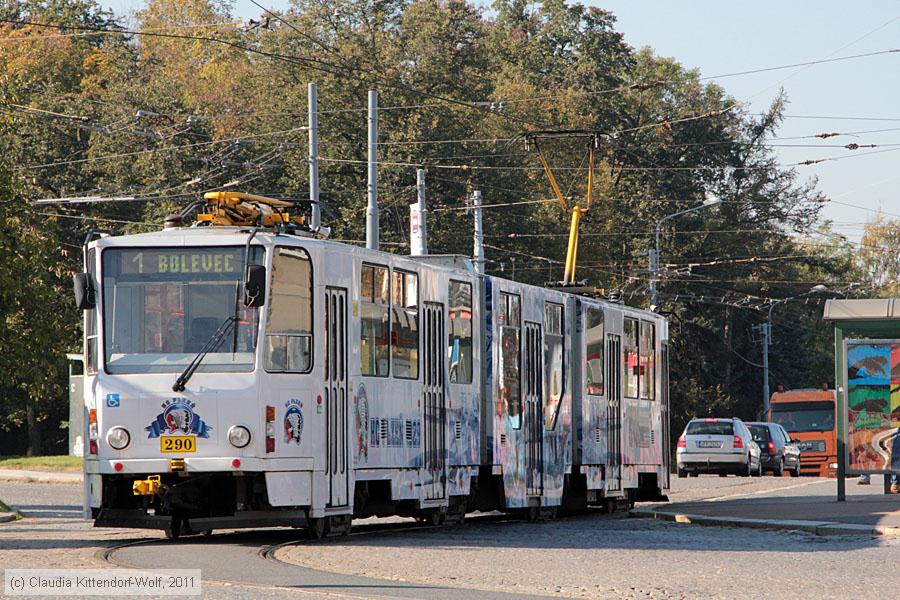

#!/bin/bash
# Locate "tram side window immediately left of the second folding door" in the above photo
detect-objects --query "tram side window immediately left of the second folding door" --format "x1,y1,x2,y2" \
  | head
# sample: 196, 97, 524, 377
391, 271, 419, 379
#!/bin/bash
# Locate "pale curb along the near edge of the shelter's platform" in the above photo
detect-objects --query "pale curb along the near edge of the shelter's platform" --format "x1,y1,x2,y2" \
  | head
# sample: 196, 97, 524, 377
628, 508, 900, 536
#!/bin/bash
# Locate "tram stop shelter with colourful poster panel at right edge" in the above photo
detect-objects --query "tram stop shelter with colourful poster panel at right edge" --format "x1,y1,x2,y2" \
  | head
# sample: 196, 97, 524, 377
825, 298, 900, 501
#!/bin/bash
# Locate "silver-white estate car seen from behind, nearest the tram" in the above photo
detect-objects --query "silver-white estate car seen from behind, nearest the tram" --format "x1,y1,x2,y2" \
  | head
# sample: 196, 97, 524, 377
675, 418, 762, 477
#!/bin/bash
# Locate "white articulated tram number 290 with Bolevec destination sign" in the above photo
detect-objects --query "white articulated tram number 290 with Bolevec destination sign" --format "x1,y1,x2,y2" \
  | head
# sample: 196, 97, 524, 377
75, 193, 669, 536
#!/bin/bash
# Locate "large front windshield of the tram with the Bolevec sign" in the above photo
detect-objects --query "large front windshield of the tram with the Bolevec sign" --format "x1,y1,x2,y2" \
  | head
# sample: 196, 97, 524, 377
102, 246, 263, 374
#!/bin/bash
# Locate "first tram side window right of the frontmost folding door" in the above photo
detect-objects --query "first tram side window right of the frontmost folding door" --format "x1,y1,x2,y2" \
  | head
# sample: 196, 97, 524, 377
359, 265, 391, 377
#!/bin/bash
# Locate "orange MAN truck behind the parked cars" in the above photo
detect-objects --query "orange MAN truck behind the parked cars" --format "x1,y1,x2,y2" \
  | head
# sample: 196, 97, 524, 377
767, 388, 837, 477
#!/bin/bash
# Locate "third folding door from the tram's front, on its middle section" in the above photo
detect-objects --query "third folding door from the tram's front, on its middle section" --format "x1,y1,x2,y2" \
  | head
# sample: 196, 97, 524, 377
523, 321, 544, 496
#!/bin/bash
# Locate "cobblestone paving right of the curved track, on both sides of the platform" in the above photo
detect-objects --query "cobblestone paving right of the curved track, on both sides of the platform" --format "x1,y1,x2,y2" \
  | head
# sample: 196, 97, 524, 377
278, 477, 900, 600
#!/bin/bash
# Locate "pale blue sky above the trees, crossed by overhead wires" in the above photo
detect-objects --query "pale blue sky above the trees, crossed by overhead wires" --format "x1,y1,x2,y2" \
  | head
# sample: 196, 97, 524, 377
101, 0, 900, 241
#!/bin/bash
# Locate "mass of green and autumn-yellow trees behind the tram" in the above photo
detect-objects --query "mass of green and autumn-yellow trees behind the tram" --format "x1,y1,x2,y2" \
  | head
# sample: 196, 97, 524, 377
0, 0, 876, 450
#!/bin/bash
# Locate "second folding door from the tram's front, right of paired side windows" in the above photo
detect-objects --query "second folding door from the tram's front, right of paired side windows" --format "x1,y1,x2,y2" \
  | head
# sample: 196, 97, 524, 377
422, 302, 447, 500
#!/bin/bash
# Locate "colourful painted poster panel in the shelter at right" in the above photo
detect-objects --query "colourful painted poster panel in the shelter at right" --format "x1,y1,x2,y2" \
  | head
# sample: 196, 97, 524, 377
847, 340, 900, 471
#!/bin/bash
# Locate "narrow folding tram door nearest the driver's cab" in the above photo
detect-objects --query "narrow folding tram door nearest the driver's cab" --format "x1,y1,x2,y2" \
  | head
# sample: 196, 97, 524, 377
325, 287, 349, 507
